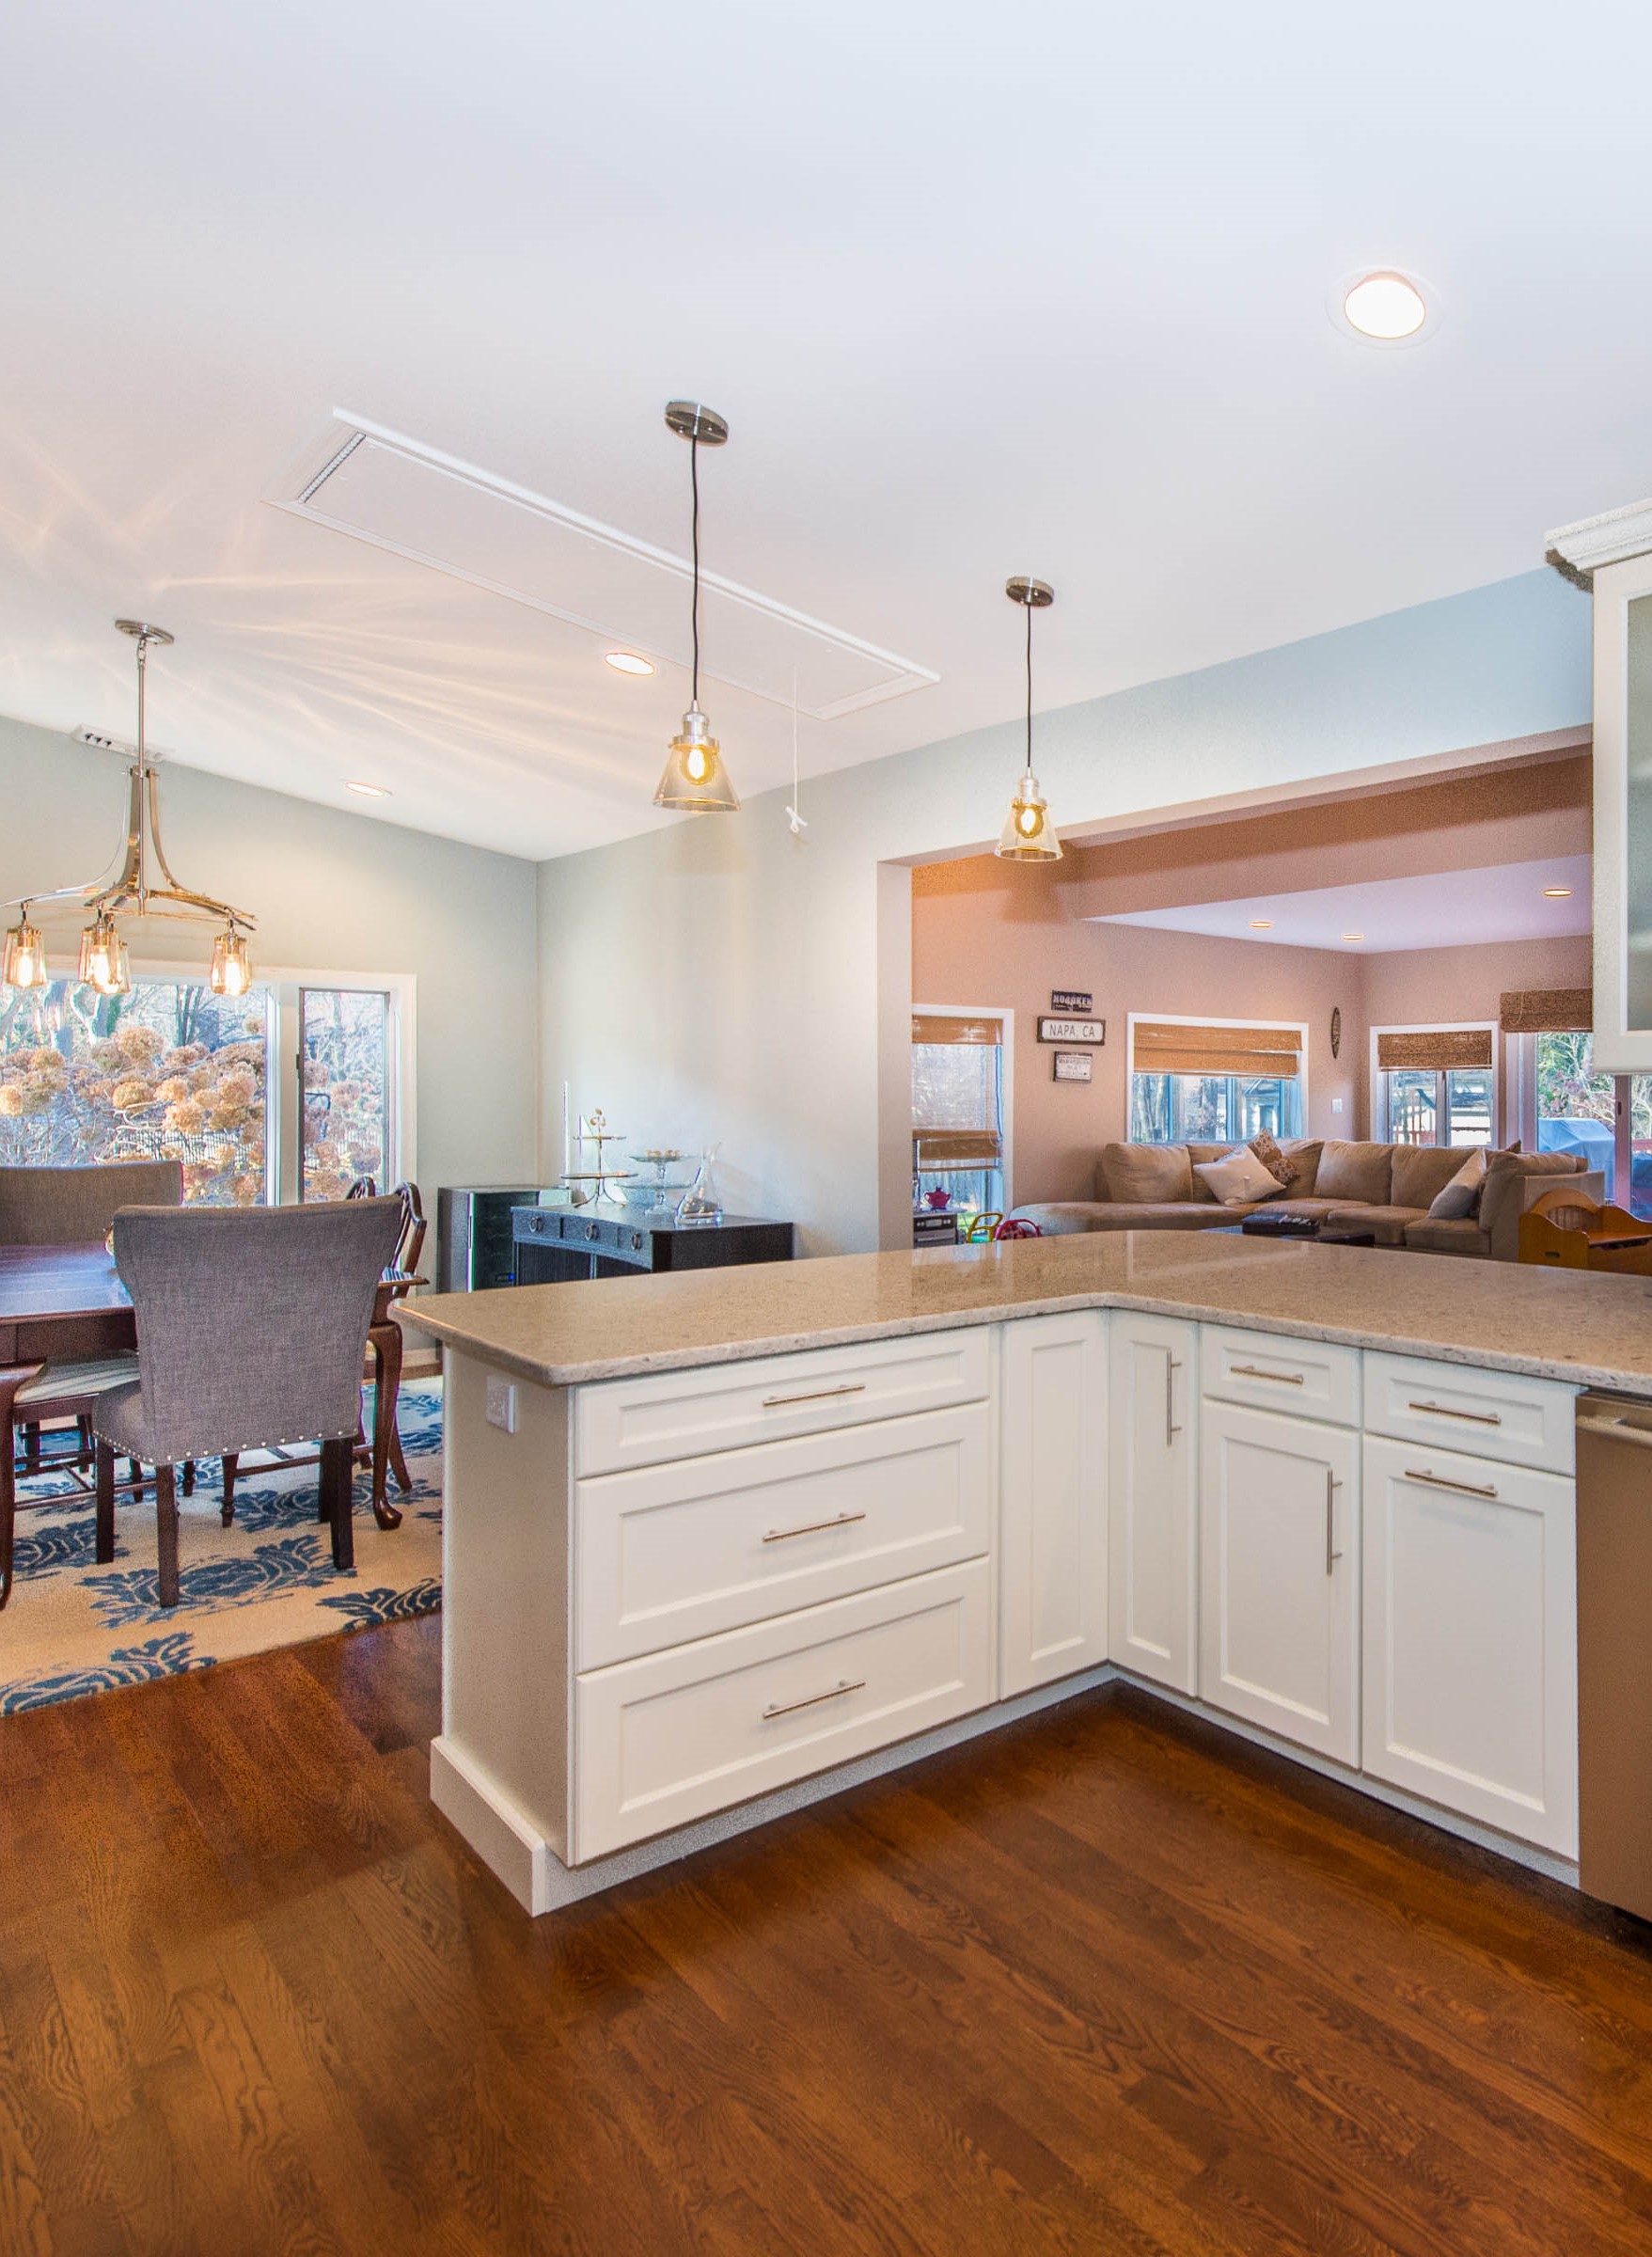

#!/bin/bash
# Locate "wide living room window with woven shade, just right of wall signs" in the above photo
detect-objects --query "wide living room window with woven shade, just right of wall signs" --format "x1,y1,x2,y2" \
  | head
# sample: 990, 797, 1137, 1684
1128, 1014, 1307, 1144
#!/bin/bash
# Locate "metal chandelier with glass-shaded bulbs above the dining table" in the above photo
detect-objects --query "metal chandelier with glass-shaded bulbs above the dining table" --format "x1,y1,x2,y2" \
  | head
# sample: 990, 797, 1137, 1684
0, 619, 258, 995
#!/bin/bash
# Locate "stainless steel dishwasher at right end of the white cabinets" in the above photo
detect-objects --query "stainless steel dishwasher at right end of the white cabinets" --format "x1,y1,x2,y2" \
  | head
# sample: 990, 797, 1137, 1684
1578, 1395, 1652, 1920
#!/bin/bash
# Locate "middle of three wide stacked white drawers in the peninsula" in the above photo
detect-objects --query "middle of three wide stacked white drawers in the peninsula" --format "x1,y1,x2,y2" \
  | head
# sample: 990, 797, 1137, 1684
574, 1404, 993, 1670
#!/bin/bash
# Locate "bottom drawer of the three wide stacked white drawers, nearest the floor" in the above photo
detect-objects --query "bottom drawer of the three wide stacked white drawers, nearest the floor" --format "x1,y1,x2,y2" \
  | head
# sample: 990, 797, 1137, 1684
571, 1559, 993, 1864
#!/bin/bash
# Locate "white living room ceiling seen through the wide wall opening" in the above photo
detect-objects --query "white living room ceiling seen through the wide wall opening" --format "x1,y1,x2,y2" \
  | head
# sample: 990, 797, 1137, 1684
1090, 853, 1591, 957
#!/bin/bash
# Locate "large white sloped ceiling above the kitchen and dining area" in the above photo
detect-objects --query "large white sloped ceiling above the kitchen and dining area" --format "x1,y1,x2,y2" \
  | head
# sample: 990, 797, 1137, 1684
0, 0, 1652, 856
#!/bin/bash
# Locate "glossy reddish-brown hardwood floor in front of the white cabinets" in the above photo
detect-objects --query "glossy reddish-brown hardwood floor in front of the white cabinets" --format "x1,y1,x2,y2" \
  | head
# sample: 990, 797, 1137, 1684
0, 1620, 1652, 2257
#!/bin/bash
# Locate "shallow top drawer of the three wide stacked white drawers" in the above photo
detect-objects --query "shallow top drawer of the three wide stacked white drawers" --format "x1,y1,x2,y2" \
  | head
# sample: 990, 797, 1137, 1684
574, 1325, 993, 1474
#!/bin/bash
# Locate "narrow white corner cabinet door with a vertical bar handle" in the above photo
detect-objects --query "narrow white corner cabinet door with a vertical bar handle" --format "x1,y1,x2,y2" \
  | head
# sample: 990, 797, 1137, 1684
1109, 1309, 1199, 1693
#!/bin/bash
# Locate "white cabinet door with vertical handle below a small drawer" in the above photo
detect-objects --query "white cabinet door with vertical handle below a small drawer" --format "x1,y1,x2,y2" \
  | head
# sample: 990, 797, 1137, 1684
1199, 1401, 1359, 1762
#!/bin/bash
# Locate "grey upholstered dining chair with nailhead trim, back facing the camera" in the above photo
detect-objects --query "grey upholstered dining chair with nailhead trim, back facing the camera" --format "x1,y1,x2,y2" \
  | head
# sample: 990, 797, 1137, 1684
92, 1198, 401, 1607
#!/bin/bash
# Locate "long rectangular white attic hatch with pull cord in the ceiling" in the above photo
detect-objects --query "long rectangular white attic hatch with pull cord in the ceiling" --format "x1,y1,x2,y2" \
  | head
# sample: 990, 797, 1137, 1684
264, 408, 939, 720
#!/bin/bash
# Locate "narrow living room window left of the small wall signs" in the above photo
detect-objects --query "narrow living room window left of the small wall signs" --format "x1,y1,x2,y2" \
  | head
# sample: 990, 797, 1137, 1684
912, 1004, 1011, 1214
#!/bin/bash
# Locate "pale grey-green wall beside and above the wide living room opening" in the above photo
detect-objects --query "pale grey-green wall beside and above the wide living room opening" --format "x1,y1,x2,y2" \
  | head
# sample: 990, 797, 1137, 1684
540, 560, 1589, 1253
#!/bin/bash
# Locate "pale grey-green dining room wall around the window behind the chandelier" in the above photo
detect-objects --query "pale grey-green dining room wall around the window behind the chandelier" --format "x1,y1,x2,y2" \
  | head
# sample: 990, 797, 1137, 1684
0, 718, 537, 1212
